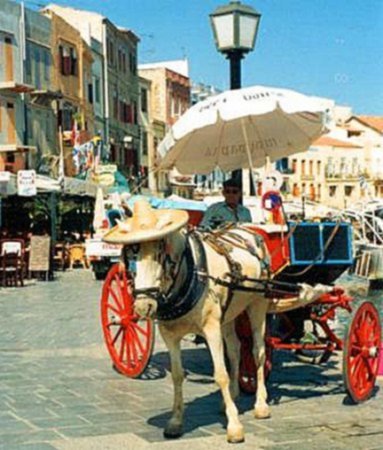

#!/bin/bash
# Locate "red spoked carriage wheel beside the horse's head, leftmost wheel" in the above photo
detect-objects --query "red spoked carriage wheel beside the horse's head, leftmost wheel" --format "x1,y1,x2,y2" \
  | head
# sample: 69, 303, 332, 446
101, 264, 154, 378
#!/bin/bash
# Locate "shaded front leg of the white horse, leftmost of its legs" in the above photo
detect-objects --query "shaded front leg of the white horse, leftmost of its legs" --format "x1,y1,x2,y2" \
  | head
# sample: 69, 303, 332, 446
160, 325, 184, 439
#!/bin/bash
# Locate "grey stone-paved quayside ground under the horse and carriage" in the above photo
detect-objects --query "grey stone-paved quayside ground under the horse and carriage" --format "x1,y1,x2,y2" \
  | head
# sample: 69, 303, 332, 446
0, 270, 383, 450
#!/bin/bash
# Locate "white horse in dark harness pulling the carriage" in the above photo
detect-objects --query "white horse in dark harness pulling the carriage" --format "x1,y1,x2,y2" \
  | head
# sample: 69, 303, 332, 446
130, 227, 325, 442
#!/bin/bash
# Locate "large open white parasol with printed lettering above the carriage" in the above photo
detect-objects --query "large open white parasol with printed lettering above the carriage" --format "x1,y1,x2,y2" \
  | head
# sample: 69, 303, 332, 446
158, 86, 328, 174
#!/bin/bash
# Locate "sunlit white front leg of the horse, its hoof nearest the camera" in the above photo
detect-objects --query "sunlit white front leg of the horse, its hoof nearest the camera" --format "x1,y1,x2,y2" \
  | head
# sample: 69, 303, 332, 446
203, 318, 245, 443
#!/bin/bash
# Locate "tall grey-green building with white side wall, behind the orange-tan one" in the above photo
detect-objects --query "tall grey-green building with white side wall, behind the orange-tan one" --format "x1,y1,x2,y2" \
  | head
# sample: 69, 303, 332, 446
45, 4, 140, 175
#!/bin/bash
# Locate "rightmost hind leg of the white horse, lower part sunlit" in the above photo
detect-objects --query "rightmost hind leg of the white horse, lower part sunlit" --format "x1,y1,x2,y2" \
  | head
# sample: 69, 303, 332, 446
247, 300, 270, 419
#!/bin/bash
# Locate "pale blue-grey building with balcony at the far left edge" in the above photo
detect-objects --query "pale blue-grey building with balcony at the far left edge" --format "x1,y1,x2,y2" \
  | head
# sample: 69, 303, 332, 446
0, 0, 57, 173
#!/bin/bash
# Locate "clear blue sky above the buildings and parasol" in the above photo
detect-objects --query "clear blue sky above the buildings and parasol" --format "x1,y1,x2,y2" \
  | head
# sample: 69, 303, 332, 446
26, 0, 383, 116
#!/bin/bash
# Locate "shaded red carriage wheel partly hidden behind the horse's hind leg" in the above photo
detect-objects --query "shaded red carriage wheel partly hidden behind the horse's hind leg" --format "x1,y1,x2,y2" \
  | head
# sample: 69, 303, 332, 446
235, 312, 272, 394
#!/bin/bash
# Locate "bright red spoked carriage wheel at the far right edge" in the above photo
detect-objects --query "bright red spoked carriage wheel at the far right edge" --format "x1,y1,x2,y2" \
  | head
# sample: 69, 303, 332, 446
343, 302, 382, 403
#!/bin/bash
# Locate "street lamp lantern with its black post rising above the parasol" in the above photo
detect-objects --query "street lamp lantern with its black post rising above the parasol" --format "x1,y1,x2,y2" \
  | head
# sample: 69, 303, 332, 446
210, 1, 261, 184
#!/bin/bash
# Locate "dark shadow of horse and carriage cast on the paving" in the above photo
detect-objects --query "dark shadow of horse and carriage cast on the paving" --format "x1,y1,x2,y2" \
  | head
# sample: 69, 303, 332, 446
148, 347, 352, 434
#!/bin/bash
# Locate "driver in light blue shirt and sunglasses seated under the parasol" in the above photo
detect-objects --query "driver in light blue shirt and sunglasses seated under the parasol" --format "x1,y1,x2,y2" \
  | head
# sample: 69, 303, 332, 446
200, 178, 251, 228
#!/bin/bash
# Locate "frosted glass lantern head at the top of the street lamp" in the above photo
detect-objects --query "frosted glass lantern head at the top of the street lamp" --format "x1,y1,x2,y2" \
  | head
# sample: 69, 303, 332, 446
210, 1, 261, 53
